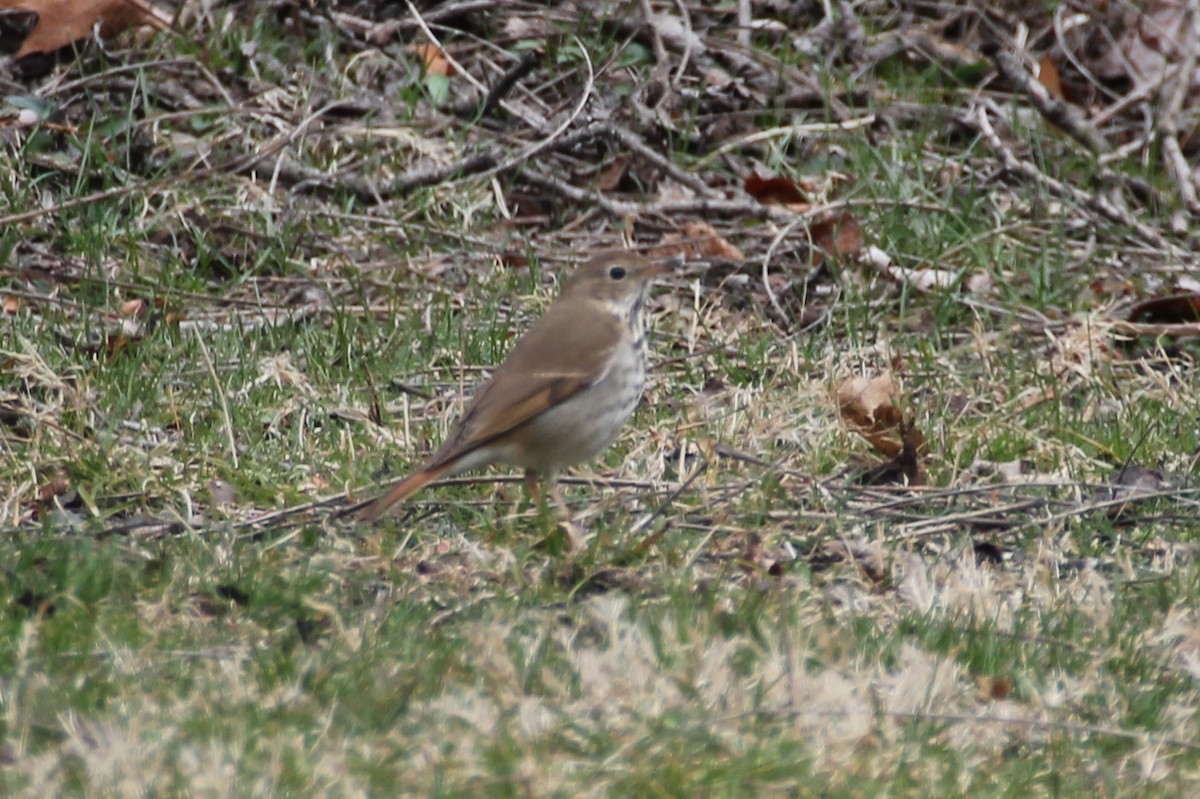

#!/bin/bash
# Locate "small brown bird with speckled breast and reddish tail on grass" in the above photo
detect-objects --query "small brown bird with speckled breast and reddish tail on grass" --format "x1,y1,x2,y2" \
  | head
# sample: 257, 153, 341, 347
362, 252, 671, 522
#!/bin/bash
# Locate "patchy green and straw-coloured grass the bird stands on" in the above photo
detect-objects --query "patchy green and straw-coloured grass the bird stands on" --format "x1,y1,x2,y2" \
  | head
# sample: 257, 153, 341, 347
0, 0, 1200, 797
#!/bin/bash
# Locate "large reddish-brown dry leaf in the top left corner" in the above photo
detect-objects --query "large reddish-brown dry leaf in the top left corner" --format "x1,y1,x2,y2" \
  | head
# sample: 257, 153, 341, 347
0, 0, 170, 59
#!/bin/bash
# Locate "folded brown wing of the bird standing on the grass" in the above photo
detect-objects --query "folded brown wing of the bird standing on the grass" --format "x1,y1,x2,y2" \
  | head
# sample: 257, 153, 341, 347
430, 299, 620, 465
